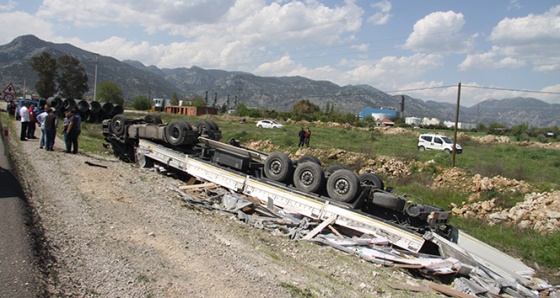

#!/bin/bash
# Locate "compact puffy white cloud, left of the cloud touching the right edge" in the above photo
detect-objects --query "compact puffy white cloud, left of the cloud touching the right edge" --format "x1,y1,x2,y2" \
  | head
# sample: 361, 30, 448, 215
404, 11, 474, 54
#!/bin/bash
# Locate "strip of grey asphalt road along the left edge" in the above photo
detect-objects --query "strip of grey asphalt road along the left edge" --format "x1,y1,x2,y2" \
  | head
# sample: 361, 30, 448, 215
0, 113, 41, 298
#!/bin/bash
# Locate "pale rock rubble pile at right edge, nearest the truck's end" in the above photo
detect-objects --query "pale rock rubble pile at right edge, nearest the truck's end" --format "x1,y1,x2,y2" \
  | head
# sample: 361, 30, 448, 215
452, 191, 560, 233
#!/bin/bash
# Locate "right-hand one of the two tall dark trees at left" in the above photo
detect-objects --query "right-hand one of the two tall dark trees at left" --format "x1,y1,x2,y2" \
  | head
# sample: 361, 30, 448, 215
57, 55, 89, 98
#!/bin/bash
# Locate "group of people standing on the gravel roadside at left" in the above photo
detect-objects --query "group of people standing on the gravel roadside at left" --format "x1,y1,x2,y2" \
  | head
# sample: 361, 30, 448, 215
18, 102, 81, 154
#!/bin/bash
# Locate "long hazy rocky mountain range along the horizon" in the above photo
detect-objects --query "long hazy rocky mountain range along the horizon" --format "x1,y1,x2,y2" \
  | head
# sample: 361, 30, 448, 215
0, 35, 560, 127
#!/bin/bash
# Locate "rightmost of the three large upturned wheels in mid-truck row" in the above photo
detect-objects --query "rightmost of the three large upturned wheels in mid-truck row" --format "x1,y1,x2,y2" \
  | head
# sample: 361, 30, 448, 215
327, 169, 361, 203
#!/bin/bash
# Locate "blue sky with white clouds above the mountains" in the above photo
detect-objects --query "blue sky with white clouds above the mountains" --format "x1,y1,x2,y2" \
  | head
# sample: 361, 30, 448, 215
0, 0, 560, 106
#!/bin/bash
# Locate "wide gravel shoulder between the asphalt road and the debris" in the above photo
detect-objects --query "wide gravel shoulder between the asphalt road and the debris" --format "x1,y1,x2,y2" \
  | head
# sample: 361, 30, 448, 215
11, 117, 434, 297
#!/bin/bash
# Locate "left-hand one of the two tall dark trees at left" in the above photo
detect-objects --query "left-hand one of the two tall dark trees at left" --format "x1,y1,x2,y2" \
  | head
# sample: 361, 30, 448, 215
31, 52, 57, 98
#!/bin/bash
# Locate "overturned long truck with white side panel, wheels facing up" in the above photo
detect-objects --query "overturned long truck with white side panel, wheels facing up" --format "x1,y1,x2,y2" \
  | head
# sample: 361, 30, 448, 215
102, 114, 556, 297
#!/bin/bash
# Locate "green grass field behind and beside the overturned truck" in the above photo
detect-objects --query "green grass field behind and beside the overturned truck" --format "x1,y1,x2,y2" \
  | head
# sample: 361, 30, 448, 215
74, 114, 560, 282
